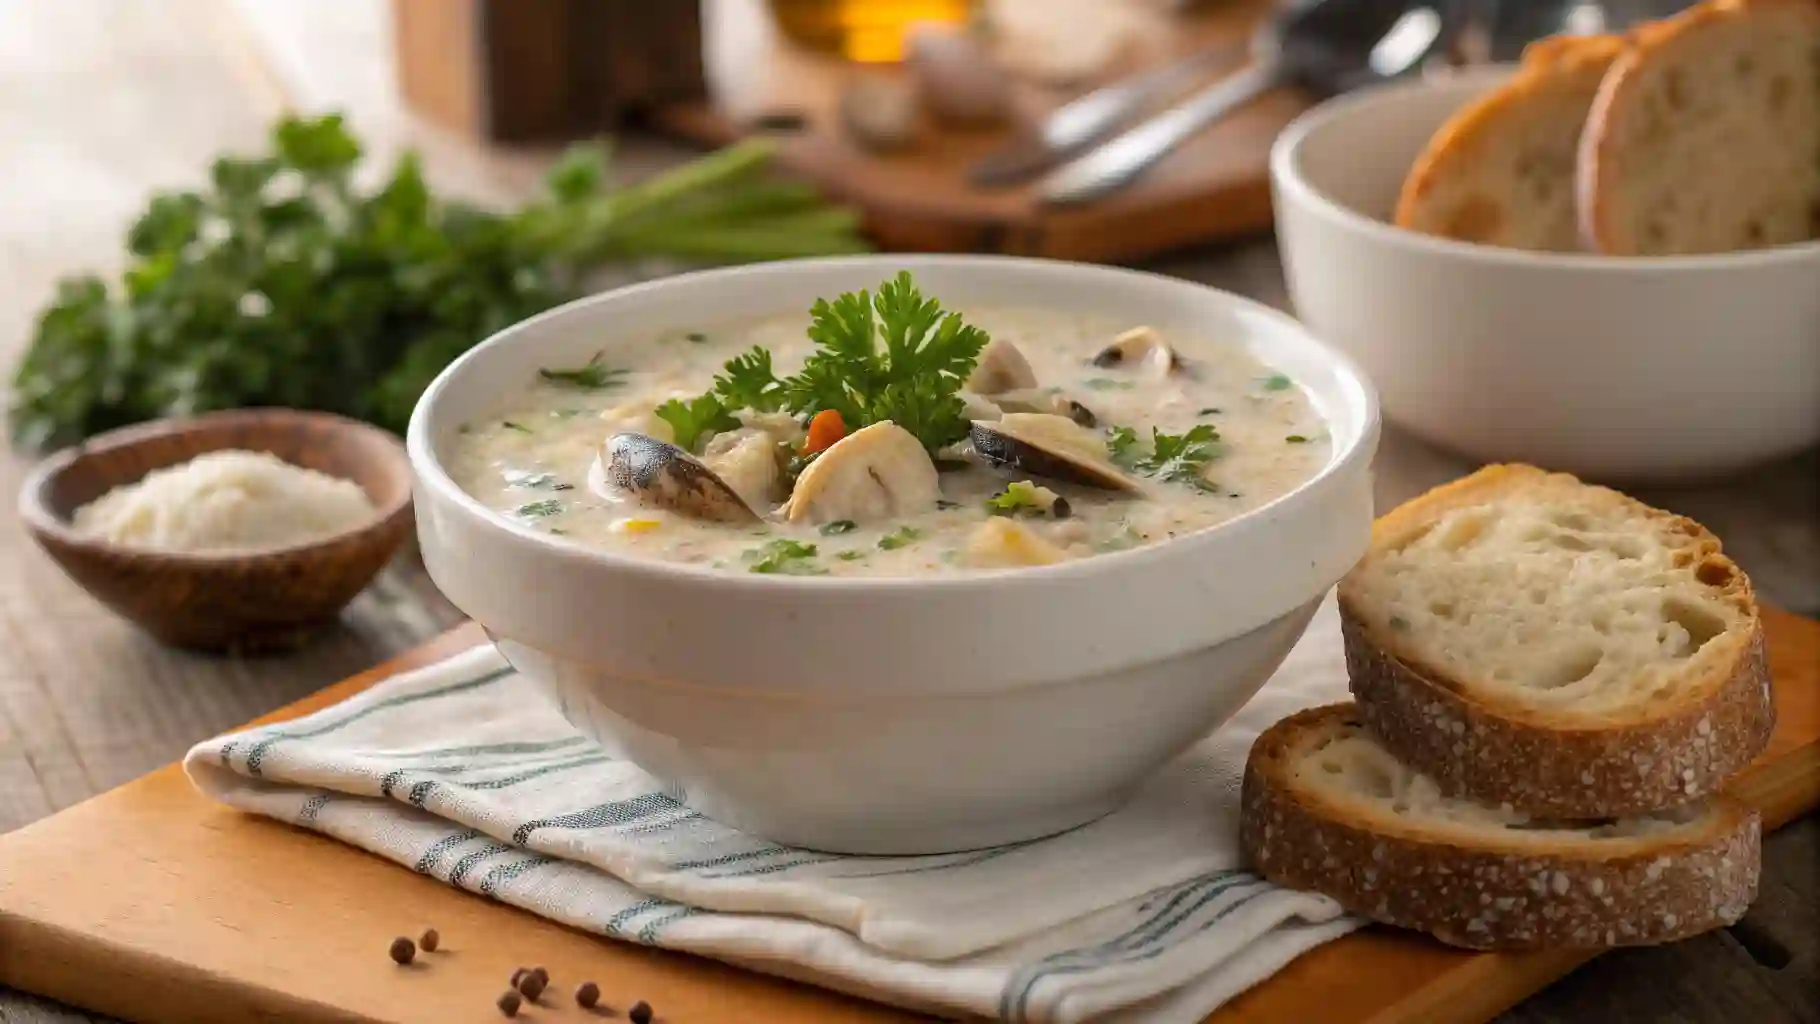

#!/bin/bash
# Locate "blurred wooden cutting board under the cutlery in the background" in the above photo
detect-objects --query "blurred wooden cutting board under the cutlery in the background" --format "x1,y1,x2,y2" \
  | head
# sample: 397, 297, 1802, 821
657, 0, 1309, 262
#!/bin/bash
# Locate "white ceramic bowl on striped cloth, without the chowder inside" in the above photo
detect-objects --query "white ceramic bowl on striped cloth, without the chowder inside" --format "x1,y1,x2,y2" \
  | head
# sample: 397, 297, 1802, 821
408, 256, 1378, 853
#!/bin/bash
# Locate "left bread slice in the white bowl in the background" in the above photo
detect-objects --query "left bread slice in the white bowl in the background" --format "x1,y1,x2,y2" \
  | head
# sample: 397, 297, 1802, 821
1396, 36, 1623, 251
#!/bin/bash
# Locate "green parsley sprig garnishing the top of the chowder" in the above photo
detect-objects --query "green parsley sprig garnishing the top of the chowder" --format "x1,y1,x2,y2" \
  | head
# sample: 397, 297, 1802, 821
657, 271, 990, 455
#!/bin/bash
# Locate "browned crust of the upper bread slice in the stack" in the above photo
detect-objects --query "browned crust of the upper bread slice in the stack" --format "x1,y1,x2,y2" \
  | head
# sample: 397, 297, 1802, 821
1340, 466, 1776, 818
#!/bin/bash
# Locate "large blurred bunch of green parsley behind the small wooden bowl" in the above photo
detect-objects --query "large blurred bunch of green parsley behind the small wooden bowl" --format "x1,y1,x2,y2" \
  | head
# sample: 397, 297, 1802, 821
11, 115, 865, 447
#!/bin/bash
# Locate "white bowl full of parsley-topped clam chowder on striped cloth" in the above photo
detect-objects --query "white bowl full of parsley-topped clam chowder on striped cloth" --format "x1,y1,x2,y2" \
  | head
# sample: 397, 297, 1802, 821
410, 256, 1378, 853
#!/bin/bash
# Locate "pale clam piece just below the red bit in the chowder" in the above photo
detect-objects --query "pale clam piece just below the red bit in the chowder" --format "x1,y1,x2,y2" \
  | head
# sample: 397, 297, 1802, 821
781, 420, 941, 522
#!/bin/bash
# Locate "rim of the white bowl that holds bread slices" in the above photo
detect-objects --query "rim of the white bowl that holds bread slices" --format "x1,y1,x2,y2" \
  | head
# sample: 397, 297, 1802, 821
1270, 64, 1820, 273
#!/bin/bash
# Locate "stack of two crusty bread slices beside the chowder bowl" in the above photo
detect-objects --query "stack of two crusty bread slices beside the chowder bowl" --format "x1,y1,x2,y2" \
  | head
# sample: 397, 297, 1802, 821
1241, 466, 1776, 949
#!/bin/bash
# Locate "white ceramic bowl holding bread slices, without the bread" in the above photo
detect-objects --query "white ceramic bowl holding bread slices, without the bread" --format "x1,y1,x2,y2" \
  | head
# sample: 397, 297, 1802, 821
1270, 69, 1820, 482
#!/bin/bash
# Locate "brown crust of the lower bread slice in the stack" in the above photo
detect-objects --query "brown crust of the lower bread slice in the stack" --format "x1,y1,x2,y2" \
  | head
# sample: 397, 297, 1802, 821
1239, 704, 1762, 949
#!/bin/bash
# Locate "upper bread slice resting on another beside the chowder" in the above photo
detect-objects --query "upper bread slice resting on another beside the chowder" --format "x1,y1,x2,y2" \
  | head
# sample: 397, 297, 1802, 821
1340, 466, 1775, 818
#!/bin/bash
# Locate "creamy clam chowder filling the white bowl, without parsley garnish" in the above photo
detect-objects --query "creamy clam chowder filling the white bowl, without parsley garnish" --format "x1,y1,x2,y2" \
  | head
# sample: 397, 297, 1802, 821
450, 280, 1330, 577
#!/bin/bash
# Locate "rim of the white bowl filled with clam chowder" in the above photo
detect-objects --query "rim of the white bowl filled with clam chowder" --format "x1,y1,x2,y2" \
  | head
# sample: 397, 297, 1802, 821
404, 253, 1381, 591
